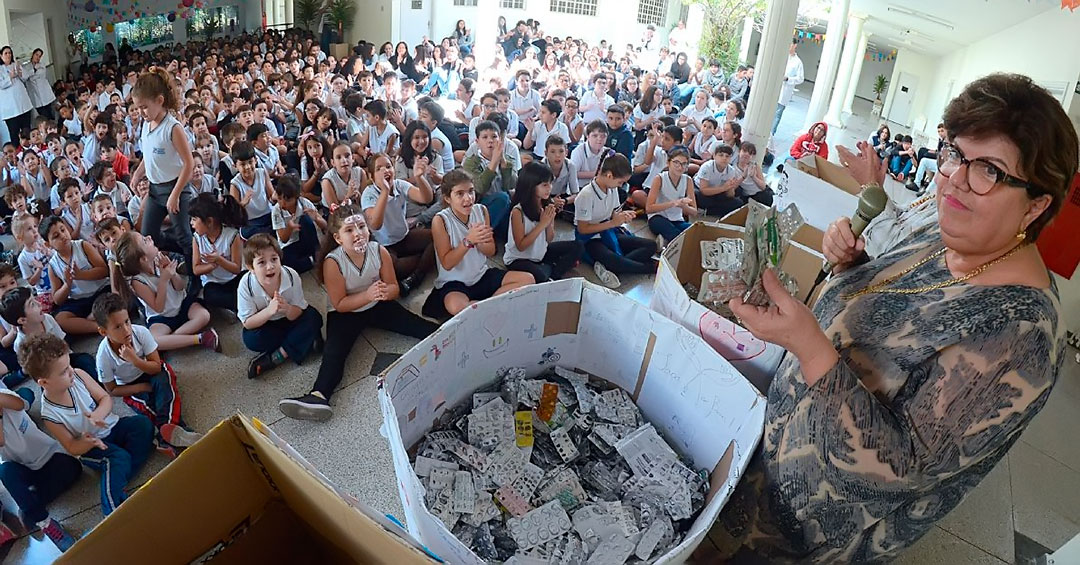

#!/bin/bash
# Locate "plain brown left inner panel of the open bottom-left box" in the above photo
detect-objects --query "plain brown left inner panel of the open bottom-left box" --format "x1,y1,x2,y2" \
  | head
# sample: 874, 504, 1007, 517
57, 421, 271, 563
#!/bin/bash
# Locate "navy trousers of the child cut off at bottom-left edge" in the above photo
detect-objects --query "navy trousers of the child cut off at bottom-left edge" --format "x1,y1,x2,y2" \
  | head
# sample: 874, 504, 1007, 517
0, 451, 82, 527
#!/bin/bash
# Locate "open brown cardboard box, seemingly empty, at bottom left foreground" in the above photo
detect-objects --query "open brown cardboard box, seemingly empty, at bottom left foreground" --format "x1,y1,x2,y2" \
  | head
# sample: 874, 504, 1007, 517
58, 415, 435, 564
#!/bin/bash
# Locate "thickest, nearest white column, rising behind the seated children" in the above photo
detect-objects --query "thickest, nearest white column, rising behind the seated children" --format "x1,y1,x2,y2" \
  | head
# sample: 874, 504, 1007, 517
743, 0, 799, 160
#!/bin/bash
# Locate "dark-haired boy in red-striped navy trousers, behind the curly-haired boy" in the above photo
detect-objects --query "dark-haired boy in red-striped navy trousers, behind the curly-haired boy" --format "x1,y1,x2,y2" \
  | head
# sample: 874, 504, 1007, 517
94, 293, 202, 452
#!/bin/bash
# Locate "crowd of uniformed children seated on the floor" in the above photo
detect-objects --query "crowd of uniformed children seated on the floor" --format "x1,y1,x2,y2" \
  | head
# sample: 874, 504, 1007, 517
0, 24, 771, 549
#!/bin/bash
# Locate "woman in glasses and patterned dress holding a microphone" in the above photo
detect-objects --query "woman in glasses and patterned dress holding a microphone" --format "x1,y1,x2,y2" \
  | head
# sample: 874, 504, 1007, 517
694, 73, 1080, 563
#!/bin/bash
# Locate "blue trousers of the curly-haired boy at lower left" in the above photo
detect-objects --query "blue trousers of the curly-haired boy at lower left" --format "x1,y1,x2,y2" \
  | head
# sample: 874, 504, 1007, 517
79, 415, 153, 515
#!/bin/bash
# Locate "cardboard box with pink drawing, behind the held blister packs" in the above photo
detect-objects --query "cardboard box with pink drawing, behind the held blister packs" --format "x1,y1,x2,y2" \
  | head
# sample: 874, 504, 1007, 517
649, 218, 824, 392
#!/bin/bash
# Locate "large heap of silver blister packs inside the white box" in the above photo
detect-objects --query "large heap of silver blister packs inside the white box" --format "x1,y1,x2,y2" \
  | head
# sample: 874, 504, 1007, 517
414, 367, 708, 565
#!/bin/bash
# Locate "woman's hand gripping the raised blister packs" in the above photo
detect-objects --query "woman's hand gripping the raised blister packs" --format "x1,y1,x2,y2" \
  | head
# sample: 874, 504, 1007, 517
728, 269, 839, 385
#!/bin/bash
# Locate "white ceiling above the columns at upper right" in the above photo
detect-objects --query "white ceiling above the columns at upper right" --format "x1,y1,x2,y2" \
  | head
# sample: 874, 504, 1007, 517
850, 0, 1061, 55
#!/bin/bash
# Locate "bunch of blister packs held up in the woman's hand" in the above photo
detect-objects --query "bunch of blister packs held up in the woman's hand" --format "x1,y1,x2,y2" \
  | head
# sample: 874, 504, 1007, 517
685, 200, 804, 317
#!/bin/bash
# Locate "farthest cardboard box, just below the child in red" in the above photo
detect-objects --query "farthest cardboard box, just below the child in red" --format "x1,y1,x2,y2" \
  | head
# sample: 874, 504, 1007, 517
775, 156, 860, 232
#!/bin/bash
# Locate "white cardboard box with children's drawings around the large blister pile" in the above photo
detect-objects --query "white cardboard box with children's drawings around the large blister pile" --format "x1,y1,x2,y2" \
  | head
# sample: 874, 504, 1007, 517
379, 279, 765, 565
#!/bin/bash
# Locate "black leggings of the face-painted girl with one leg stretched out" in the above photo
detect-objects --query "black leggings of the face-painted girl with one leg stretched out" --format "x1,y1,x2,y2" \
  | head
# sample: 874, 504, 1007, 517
311, 300, 438, 400
